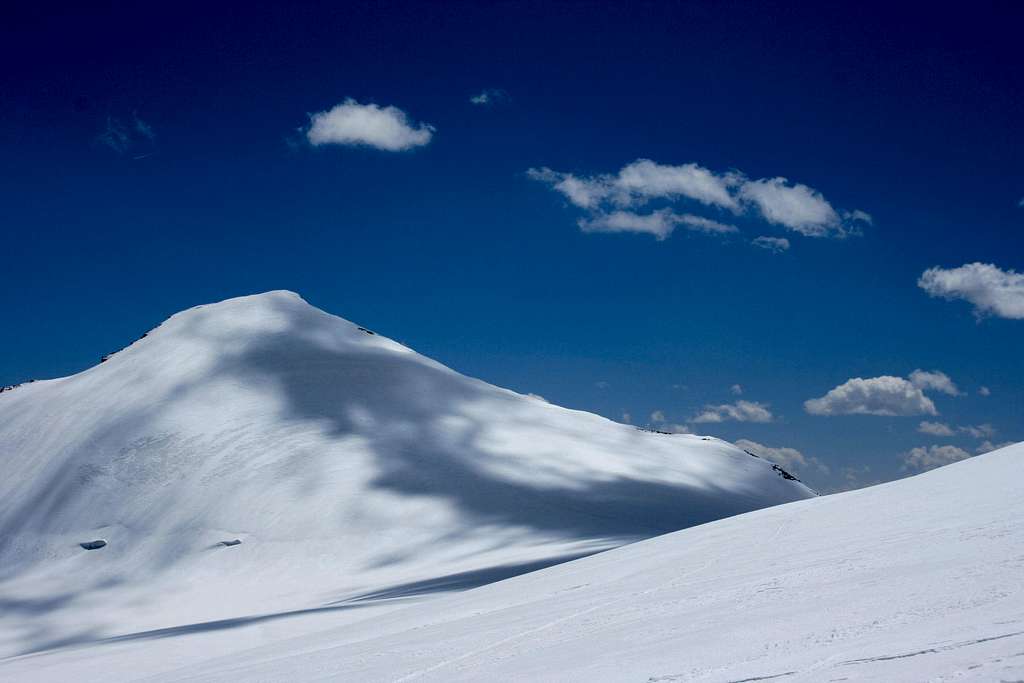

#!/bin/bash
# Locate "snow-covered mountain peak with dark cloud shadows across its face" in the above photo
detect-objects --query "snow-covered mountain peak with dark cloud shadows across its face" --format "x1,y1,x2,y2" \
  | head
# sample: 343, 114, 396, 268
0, 292, 811, 667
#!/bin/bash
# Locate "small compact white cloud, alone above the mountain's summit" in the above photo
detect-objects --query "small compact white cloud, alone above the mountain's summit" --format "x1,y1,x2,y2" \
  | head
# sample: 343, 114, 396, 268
306, 97, 434, 152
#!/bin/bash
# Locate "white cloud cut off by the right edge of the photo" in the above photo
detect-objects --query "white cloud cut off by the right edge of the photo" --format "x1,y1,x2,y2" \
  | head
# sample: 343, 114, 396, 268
918, 263, 1024, 319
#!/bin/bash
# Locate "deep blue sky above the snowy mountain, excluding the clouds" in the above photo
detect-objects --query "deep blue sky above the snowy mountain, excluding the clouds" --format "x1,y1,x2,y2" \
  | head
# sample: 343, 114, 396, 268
0, 2, 1024, 488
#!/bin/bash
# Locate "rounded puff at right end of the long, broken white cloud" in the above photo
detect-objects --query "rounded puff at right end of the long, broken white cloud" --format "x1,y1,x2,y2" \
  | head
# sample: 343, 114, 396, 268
739, 178, 848, 238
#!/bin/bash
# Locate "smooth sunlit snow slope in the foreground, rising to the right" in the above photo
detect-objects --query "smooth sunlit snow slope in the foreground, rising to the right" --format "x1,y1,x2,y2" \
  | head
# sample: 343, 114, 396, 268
142, 443, 1024, 682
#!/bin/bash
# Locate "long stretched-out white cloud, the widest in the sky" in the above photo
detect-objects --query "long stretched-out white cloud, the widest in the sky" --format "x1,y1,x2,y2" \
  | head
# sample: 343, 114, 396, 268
526, 159, 871, 241
